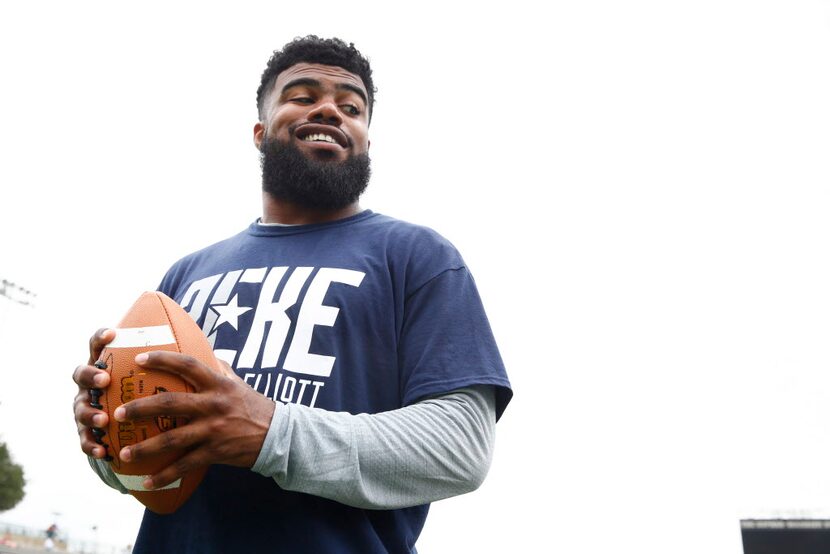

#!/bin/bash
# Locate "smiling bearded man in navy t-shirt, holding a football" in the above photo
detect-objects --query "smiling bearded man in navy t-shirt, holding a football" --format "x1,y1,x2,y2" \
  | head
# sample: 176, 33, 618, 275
74, 36, 512, 554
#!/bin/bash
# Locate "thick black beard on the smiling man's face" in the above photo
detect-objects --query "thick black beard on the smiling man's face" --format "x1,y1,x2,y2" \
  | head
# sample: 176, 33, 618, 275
260, 137, 371, 210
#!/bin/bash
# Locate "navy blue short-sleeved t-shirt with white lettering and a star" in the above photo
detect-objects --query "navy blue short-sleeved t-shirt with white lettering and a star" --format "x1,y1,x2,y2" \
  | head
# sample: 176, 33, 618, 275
135, 210, 512, 554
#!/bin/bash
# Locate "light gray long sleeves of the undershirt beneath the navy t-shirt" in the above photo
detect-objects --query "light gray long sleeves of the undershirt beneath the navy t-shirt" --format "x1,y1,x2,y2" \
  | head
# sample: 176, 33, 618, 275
89, 385, 496, 509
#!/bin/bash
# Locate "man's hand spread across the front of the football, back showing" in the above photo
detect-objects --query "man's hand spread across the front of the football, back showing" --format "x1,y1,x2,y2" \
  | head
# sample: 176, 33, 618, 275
113, 351, 276, 488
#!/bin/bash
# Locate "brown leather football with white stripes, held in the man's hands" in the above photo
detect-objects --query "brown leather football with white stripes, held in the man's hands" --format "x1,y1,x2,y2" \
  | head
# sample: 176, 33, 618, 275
90, 292, 222, 514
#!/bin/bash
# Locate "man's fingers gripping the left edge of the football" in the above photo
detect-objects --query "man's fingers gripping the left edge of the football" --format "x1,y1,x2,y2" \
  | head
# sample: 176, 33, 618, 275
72, 328, 118, 459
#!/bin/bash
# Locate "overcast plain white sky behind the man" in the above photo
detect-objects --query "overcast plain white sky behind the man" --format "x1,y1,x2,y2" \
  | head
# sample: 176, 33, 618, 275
0, 0, 830, 554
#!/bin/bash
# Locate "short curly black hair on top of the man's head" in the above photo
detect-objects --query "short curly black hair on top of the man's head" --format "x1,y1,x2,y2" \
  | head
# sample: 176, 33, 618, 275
256, 35, 377, 121
